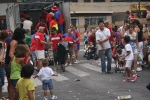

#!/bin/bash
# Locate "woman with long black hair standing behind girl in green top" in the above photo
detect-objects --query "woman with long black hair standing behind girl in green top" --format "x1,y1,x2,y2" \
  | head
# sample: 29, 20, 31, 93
5, 28, 29, 100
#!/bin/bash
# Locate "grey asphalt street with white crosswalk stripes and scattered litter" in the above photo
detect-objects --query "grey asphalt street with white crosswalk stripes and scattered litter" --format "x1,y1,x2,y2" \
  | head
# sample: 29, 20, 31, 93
3, 50, 150, 100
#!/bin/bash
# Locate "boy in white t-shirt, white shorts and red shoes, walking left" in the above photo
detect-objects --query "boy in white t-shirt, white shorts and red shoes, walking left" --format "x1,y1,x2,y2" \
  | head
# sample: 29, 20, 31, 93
121, 36, 137, 82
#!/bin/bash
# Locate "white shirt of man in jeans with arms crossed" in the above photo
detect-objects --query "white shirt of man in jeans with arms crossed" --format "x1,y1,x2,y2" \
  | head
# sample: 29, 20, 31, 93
96, 28, 111, 50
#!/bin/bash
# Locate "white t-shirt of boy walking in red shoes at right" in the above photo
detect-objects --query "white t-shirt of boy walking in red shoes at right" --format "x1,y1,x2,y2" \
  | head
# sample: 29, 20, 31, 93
125, 44, 134, 60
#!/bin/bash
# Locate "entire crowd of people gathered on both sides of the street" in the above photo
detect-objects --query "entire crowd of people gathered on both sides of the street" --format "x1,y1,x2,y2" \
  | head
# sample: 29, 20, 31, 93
0, 1, 150, 100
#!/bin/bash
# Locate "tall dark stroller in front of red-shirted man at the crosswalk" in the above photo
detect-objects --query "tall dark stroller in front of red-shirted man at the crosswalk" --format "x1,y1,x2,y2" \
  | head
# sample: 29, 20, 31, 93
57, 42, 69, 72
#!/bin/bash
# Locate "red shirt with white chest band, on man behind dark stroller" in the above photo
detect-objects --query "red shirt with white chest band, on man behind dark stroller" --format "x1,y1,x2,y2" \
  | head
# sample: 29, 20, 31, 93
50, 34, 62, 50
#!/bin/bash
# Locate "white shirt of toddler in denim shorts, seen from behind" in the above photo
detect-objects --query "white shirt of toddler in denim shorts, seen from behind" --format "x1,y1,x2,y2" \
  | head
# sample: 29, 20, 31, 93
37, 67, 54, 80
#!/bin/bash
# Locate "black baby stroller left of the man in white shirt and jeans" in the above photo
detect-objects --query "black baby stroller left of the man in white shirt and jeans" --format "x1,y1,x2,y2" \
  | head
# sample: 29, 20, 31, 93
83, 47, 98, 60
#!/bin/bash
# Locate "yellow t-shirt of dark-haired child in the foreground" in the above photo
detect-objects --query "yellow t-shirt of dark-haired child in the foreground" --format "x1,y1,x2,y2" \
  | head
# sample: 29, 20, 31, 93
16, 78, 35, 100
